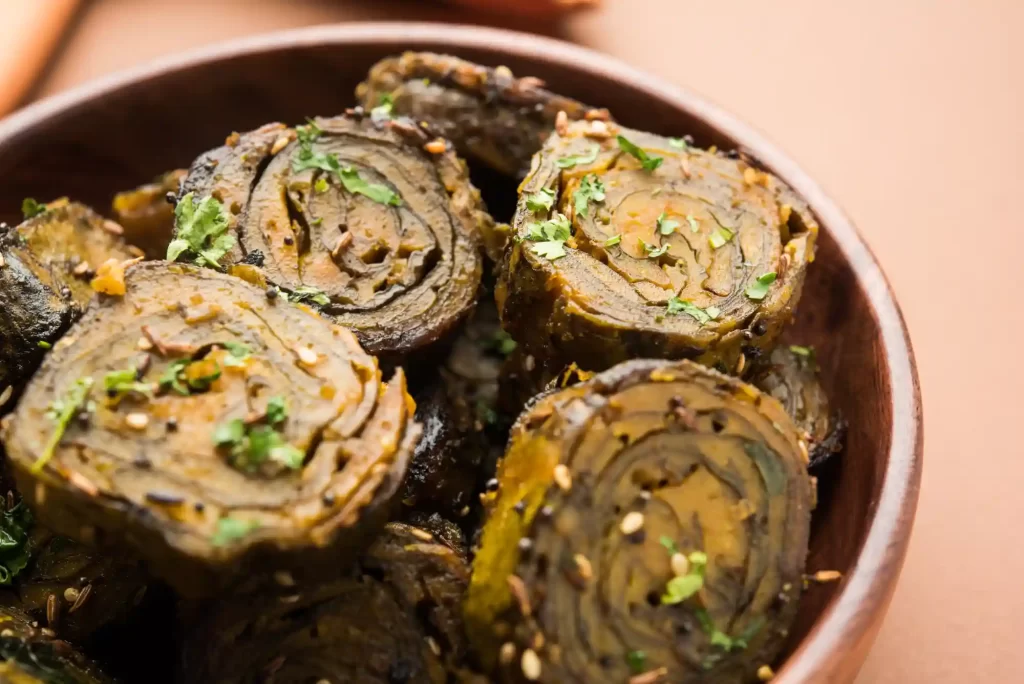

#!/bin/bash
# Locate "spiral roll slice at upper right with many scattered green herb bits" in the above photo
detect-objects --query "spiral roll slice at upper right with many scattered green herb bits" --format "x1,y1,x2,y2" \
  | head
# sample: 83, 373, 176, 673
497, 121, 818, 373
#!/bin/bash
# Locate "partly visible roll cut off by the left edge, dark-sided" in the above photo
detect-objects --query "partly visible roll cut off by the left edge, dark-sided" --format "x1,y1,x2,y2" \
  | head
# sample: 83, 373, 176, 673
0, 200, 142, 409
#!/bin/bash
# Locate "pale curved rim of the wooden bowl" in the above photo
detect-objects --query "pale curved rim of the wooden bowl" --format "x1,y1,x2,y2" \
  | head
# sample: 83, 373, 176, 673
0, 22, 924, 684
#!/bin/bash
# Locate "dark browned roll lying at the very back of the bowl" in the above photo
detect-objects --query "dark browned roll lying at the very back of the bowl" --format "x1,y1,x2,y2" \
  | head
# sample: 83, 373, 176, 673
355, 52, 607, 177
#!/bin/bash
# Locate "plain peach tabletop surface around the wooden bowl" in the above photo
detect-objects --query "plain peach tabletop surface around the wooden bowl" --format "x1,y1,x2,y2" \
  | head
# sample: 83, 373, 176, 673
8, 0, 1024, 684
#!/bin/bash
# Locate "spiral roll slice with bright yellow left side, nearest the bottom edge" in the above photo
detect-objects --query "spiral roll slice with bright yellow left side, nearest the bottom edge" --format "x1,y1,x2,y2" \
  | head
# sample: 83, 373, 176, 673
466, 360, 812, 684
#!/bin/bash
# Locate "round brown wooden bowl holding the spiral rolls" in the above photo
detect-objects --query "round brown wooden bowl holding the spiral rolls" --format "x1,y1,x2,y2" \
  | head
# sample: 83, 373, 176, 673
0, 24, 923, 684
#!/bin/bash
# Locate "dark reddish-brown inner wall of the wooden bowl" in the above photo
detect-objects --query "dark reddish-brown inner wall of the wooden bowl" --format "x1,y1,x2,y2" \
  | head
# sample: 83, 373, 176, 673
0, 31, 892, 679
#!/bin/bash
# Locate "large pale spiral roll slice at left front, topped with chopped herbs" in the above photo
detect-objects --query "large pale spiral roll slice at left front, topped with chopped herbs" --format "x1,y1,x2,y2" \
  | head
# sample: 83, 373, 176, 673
3, 262, 420, 595
